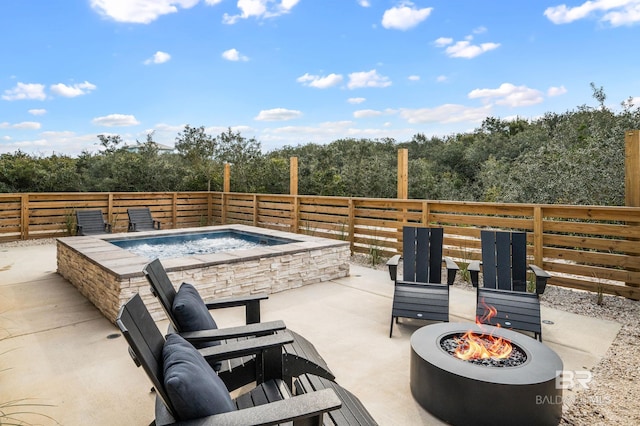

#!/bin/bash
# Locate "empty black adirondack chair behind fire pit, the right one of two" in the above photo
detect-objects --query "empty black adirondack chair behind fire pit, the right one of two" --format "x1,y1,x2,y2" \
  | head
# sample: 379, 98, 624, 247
469, 230, 550, 341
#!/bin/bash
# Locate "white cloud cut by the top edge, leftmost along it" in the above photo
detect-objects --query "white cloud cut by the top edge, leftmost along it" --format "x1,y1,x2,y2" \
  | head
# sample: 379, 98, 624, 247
91, 0, 199, 24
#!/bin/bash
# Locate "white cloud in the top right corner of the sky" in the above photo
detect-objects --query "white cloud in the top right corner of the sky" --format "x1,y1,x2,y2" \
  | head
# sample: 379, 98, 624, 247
544, 0, 640, 27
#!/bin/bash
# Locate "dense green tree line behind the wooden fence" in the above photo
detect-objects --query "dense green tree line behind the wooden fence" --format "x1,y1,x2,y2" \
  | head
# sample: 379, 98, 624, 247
0, 91, 640, 205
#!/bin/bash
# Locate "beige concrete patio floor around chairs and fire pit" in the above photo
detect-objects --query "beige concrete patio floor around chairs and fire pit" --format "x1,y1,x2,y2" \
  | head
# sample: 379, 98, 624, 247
0, 244, 620, 425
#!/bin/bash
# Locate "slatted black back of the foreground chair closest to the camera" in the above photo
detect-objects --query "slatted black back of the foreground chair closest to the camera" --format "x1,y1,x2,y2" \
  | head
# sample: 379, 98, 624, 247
116, 294, 175, 413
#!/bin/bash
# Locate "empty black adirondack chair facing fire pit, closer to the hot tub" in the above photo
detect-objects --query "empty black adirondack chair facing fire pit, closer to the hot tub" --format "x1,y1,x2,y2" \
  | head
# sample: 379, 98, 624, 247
387, 226, 459, 337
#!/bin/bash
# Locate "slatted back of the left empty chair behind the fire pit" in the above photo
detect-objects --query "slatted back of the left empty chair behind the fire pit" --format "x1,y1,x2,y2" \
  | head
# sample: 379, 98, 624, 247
402, 226, 444, 284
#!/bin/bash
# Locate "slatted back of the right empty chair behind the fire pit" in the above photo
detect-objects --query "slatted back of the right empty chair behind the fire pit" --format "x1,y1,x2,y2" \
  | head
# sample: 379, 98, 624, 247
480, 230, 527, 291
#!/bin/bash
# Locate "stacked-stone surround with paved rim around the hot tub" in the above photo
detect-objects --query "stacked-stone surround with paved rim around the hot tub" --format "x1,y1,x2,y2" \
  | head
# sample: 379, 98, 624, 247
57, 225, 350, 322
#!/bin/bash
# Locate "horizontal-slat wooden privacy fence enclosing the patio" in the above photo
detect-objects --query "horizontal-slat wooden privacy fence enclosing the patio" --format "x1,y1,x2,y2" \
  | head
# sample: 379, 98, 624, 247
0, 192, 640, 300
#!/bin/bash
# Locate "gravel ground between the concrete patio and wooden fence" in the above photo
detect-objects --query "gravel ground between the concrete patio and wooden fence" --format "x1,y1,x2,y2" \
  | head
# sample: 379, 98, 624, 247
6, 239, 640, 426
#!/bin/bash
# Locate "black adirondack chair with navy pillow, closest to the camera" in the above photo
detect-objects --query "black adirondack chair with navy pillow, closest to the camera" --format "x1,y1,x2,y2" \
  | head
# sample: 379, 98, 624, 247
116, 294, 376, 426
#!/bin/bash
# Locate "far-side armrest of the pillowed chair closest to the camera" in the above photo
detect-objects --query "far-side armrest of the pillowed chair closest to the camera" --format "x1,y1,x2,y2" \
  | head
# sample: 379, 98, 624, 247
198, 331, 293, 364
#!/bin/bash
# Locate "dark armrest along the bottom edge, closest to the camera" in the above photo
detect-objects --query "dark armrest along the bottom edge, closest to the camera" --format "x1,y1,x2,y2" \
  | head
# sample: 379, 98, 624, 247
161, 389, 342, 426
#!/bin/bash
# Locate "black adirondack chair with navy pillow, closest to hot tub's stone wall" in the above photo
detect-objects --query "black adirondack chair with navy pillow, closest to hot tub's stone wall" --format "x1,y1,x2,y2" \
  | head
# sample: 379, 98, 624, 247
143, 259, 335, 389
